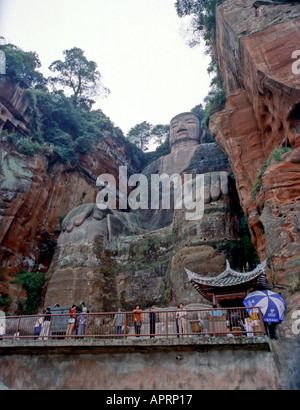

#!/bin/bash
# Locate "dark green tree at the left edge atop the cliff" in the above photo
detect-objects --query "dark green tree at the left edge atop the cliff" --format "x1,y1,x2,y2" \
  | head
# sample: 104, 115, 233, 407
0, 37, 47, 87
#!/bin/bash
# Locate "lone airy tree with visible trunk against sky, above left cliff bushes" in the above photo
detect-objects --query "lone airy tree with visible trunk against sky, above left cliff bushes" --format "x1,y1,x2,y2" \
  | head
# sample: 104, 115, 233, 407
49, 47, 109, 107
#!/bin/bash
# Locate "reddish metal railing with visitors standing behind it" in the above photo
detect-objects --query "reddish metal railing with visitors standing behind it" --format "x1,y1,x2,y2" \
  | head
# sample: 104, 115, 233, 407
0, 308, 265, 340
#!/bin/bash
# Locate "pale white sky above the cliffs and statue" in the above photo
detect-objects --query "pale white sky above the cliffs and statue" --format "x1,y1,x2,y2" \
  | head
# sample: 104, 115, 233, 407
0, 0, 210, 134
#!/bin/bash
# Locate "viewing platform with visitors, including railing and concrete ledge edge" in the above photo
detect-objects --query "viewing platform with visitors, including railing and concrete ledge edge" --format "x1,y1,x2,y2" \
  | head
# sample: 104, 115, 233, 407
0, 308, 270, 355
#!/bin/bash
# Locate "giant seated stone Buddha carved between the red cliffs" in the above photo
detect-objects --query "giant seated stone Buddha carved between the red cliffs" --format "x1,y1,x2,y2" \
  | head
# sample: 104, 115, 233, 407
44, 112, 239, 311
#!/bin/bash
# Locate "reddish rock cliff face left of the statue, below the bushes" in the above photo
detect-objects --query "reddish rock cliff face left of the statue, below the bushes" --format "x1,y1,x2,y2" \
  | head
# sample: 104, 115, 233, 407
0, 135, 137, 310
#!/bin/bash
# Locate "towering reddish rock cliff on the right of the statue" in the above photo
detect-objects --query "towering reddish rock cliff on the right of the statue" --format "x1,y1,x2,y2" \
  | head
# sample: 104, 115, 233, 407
210, 0, 300, 390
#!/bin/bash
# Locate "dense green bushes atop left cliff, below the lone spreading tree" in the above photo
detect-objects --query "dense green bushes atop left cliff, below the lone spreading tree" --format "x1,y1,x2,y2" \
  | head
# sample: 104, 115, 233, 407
28, 90, 118, 163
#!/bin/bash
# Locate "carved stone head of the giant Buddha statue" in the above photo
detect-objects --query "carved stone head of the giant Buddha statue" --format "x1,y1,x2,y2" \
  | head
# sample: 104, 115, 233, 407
170, 113, 200, 149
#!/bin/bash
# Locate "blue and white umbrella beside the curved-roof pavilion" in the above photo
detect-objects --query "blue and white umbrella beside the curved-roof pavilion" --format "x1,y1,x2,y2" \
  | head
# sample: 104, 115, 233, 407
243, 290, 286, 322
